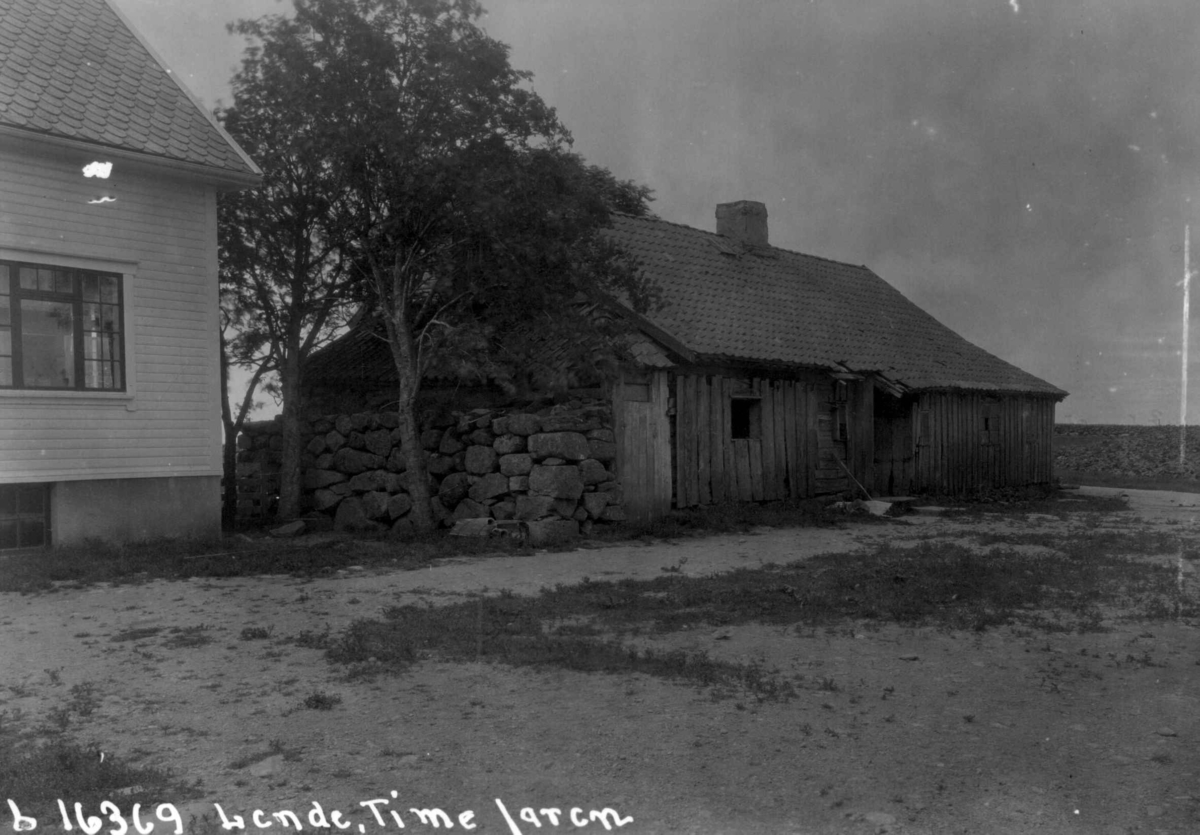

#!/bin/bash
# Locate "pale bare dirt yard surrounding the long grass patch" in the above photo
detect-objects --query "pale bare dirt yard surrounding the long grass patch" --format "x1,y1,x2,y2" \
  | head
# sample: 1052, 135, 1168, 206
7, 488, 1200, 835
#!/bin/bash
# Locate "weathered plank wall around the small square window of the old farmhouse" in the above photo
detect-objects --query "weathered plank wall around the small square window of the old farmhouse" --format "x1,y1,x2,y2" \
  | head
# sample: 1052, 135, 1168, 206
674, 373, 854, 507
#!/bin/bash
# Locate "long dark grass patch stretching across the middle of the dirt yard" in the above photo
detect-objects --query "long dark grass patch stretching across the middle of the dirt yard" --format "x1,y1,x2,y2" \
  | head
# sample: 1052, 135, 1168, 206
329, 534, 1195, 698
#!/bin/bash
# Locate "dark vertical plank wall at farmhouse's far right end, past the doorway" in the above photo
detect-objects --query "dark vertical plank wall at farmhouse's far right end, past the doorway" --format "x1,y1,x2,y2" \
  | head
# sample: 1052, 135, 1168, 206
913, 392, 1055, 494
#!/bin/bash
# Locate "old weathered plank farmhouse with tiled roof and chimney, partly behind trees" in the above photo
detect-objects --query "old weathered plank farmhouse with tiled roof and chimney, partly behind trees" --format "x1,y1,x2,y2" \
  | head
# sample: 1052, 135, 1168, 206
306, 200, 1067, 517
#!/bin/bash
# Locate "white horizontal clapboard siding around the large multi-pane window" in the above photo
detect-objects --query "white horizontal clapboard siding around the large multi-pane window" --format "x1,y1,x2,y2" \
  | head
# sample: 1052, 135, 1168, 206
0, 148, 221, 482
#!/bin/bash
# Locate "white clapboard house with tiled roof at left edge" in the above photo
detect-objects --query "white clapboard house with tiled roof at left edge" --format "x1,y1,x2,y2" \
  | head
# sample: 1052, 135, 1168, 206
0, 0, 259, 549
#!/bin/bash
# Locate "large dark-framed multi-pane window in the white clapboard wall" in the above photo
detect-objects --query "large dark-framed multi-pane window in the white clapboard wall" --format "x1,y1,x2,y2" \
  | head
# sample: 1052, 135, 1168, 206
0, 262, 125, 391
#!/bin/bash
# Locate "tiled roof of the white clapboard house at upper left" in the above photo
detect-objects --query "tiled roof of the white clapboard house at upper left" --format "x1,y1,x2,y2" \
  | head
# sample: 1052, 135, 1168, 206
0, 0, 258, 176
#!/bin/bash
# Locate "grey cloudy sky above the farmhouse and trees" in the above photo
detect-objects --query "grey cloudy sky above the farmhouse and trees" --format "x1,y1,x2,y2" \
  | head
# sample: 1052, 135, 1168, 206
116, 0, 1200, 423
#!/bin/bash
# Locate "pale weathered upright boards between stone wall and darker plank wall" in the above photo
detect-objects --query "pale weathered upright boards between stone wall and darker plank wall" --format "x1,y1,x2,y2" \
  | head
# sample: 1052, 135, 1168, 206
612, 371, 671, 521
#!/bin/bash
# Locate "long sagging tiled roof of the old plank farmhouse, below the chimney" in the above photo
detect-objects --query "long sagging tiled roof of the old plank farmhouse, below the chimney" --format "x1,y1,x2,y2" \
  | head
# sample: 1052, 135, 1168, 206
611, 215, 1067, 398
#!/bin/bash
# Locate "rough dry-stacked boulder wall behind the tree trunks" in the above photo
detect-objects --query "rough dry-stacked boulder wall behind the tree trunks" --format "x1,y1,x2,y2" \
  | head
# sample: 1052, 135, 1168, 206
238, 398, 625, 533
